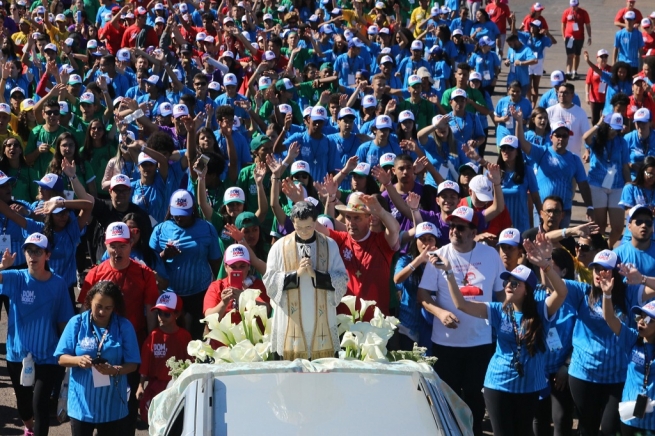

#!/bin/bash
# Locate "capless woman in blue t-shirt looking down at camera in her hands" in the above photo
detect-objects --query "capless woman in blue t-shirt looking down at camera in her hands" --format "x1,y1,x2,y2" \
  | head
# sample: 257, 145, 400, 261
54, 280, 141, 436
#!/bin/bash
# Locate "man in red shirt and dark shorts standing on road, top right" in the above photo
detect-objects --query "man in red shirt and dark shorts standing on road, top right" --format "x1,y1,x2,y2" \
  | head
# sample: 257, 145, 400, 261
562, 0, 591, 80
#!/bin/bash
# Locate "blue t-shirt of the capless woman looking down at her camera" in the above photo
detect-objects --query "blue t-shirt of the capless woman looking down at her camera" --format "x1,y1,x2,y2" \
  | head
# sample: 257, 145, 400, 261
54, 310, 141, 423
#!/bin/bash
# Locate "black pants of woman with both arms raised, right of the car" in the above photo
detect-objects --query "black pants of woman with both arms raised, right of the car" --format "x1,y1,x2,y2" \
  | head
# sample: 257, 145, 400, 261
484, 388, 539, 436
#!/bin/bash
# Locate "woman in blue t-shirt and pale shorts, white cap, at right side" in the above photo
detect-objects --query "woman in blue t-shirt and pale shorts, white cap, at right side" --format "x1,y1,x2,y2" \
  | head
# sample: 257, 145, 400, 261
582, 114, 632, 247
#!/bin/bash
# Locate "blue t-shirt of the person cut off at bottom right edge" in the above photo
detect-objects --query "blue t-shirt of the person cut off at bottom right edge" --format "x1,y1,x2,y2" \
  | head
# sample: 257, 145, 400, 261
618, 324, 655, 433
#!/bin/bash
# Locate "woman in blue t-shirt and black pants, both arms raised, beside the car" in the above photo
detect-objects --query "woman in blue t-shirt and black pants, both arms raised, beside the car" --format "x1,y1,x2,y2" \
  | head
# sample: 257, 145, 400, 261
438, 233, 567, 436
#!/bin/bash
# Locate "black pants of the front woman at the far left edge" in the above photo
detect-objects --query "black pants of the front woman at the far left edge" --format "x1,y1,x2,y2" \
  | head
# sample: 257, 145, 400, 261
7, 362, 64, 436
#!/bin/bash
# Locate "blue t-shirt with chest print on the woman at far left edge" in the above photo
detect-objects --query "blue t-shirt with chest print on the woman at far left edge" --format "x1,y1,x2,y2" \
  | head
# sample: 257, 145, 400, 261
0, 269, 73, 365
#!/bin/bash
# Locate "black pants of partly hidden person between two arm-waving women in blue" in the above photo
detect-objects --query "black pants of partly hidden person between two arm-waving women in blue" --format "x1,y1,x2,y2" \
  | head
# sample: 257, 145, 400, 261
532, 374, 574, 436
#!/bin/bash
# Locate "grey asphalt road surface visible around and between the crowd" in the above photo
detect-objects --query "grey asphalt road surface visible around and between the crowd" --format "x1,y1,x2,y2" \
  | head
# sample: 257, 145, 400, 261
0, 0, 624, 436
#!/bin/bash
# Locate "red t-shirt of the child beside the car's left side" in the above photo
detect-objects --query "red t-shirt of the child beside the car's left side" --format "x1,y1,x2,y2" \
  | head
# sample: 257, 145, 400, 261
139, 327, 191, 381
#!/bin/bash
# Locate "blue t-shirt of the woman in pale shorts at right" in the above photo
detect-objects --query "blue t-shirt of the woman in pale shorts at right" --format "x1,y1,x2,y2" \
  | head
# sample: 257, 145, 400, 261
587, 135, 630, 190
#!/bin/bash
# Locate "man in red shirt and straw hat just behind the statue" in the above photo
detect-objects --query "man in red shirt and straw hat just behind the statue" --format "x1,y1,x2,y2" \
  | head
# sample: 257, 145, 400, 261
316, 194, 400, 321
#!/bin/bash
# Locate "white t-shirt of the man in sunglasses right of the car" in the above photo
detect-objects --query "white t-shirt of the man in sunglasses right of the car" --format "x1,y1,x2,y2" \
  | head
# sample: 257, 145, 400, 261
419, 243, 505, 347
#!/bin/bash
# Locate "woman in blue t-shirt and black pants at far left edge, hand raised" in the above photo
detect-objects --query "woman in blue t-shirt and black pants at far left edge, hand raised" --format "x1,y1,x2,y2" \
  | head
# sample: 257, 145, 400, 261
0, 233, 73, 436
